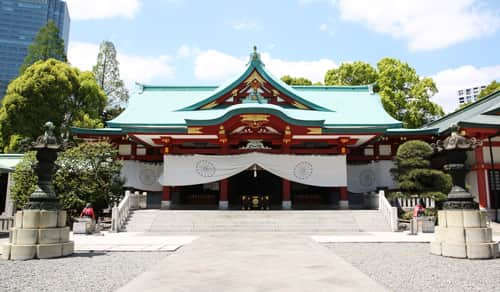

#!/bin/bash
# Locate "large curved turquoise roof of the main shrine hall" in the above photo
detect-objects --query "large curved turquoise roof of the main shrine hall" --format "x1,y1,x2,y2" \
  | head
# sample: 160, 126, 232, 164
107, 48, 401, 131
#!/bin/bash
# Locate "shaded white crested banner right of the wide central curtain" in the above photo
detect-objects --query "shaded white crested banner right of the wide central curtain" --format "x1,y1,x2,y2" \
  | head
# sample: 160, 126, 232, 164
347, 160, 396, 193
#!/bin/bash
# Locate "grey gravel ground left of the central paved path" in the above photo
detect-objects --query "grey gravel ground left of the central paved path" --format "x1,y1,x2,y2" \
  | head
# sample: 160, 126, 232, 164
0, 252, 170, 292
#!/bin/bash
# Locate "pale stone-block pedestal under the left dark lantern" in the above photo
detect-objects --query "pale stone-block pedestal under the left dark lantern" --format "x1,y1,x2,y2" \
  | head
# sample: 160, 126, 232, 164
2, 209, 74, 260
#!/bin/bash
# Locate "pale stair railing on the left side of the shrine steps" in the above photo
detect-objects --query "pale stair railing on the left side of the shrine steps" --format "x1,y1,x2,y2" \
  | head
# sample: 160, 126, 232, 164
111, 191, 147, 232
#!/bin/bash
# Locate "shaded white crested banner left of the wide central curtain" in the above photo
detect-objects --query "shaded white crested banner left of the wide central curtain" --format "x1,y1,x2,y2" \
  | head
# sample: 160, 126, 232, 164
121, 160, 163, 192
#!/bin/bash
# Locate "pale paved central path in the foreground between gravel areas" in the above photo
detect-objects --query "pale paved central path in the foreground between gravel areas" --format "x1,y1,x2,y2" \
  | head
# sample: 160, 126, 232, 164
118, 232, 386, 292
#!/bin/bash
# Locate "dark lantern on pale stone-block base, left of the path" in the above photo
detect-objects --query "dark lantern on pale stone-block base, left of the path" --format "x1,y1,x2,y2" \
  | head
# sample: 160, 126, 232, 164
2, 122, 74, 260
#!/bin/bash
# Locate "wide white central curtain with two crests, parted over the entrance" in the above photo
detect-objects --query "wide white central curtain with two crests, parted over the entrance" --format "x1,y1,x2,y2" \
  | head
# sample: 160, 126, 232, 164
159, 152, 347, 187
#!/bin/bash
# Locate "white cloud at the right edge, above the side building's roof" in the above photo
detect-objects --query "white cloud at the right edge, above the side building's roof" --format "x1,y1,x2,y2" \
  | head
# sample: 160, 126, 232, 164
432, 65, 500, 113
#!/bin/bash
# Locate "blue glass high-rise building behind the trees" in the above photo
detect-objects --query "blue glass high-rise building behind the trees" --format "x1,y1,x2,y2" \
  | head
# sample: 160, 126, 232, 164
0, 0, 70, 99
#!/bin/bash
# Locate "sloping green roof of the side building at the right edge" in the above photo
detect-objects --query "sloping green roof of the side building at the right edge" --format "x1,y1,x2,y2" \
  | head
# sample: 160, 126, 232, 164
423, 90, 500, 133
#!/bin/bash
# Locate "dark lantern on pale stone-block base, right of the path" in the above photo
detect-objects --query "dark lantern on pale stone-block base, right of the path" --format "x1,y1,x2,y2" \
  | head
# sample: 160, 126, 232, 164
431, 127, 498, 259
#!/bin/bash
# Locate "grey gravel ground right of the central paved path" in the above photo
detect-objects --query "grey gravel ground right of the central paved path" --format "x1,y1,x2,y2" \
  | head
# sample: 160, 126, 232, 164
326, 243, 500, 291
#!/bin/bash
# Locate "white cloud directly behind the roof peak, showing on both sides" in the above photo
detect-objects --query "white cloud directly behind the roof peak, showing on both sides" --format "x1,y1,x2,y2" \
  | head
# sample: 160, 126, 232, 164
194, 50, 337, 82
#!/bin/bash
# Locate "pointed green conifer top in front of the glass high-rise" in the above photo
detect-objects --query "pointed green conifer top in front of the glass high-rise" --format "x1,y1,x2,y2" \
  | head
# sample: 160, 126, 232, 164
19, 20, 67, 74
